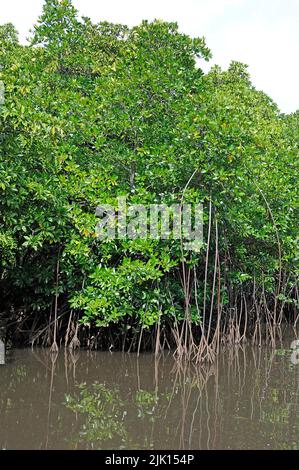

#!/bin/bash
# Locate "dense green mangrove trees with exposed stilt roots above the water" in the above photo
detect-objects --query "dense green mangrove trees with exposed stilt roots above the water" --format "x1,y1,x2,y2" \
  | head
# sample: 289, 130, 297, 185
0, 0, 299, 359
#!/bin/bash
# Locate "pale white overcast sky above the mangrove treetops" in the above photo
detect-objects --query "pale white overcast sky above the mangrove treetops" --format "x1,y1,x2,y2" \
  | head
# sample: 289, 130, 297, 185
0, 0, 299, 113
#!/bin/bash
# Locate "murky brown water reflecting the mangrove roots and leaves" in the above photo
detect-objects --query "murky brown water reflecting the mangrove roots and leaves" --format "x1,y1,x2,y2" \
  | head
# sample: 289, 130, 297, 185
0, 347, 299, 450
